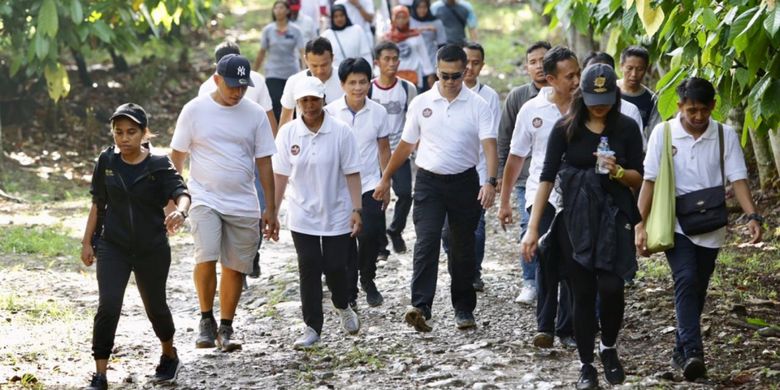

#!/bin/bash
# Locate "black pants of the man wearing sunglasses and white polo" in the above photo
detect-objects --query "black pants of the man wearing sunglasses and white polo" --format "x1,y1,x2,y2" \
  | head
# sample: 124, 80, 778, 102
412, 168, 481, 318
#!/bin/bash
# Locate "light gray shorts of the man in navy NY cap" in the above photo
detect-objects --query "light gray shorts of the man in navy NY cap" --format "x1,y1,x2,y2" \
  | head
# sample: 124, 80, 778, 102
190, 205, 260, 274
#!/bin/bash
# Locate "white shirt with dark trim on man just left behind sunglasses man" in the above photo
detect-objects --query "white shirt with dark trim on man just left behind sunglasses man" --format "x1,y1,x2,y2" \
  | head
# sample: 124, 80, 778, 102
371, 77, 417, 150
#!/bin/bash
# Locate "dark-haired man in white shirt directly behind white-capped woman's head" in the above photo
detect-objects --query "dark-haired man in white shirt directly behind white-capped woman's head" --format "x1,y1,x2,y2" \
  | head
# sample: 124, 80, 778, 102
279, 37, 344, 127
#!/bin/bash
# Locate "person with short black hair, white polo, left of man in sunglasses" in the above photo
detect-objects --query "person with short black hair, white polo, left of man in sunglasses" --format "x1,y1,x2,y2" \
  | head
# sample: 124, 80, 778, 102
325, 58, 390, 309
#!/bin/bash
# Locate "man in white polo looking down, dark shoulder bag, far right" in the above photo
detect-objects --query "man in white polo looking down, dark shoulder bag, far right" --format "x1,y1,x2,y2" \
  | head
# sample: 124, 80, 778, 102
634, 77, 764, 381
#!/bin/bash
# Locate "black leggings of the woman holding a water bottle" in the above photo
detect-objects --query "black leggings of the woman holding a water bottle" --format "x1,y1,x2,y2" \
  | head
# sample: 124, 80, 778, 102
557, 224, 625, 363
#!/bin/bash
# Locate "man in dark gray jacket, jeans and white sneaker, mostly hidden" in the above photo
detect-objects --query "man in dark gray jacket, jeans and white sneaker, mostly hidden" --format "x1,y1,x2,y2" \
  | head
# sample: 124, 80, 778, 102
498, 41, 551, 305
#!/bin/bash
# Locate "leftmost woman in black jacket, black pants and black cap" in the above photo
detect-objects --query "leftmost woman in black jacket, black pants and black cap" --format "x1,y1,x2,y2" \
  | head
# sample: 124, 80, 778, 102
81, 103, 190, 389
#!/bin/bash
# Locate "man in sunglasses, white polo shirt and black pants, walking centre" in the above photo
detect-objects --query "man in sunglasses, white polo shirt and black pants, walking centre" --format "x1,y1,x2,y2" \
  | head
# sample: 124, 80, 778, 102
374, 45, 498, 332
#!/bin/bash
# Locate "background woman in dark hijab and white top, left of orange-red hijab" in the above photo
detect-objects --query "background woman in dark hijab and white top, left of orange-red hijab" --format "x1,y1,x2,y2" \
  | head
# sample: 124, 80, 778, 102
321, 4, 373, 69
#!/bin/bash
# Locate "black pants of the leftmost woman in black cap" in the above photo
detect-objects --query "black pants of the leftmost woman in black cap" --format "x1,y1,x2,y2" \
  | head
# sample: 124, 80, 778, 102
92, 240, 176, 360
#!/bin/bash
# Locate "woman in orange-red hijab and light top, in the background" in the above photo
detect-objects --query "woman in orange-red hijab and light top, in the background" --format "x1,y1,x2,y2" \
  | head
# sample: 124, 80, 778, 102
384, 5, 436, 88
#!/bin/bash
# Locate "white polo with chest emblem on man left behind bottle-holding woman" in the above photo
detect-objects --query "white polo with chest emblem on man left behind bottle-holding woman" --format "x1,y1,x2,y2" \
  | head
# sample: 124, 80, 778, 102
509, 87, 563, 210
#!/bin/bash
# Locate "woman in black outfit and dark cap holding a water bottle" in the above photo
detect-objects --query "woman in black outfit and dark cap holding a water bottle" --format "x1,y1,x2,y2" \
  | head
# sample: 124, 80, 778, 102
521, 64, 642, 389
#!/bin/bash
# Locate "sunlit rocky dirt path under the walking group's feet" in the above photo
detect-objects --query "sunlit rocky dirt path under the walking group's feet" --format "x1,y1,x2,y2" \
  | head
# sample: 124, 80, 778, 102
0, 203, 768, 389
